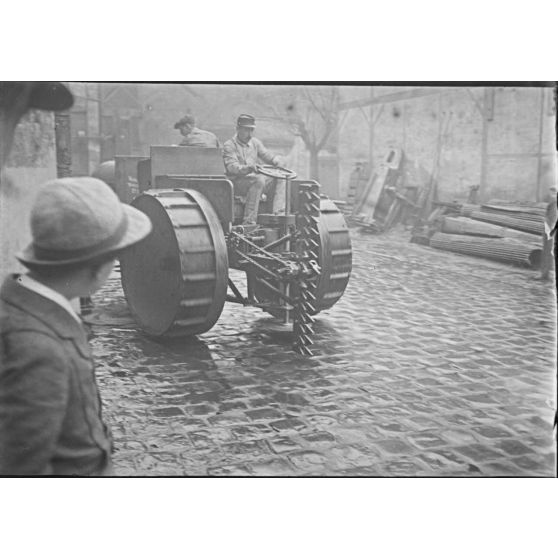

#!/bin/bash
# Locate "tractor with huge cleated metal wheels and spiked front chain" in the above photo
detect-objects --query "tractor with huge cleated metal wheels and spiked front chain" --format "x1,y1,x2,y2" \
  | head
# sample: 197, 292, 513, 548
115, 146, 352, 355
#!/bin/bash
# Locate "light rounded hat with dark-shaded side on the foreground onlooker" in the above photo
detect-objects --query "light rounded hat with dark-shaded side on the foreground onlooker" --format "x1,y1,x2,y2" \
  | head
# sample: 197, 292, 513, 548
17, 177, 152, 266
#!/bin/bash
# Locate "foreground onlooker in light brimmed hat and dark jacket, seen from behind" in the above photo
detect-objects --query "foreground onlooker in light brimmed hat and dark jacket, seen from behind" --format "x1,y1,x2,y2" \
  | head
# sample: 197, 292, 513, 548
0, 177, 151, 475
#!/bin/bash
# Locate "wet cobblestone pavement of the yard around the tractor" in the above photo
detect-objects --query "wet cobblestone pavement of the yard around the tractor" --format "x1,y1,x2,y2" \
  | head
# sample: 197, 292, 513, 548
86, 232, 556, 476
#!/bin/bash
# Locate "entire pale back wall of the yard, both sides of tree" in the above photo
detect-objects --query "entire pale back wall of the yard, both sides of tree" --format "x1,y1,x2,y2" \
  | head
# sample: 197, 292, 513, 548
64, 84, 556, 206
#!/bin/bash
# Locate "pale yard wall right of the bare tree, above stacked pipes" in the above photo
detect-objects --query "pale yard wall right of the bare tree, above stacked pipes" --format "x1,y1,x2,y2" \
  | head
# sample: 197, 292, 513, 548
340, 87, 556, 201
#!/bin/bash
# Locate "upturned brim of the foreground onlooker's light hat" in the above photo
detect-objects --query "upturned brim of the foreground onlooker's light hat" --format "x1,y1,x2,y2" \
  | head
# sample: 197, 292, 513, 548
16, 205, 153, 267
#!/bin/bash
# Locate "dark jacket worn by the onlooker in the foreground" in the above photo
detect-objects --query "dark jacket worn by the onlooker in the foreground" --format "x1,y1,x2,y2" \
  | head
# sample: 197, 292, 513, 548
0, 276, 112, 476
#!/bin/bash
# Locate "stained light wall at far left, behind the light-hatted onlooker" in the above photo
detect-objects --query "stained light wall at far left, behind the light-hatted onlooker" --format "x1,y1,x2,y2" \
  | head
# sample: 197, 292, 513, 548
0, 111, 56, 276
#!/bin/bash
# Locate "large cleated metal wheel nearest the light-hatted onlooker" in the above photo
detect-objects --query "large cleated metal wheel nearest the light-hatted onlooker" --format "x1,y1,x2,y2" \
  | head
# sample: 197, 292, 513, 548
120, 189, 229, 337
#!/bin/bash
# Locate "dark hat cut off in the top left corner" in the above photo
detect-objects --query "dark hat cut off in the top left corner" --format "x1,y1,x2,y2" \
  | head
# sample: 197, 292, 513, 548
0, 81, 74, 111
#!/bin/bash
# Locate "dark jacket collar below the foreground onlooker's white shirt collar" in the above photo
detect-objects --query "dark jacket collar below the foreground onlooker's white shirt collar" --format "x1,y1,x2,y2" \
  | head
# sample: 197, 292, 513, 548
0, 275, 87, 343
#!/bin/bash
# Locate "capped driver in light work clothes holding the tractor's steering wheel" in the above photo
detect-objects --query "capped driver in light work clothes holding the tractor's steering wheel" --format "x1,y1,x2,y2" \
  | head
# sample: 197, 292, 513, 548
223, 114, 285, 225
